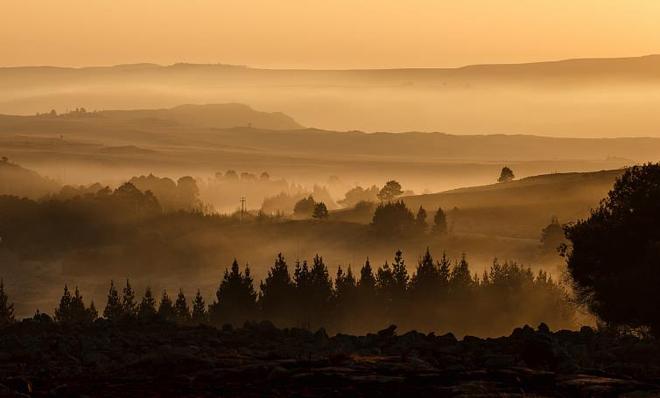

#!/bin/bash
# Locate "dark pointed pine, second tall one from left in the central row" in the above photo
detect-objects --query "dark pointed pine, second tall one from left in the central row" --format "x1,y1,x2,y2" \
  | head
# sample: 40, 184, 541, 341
259, 253, 295, 326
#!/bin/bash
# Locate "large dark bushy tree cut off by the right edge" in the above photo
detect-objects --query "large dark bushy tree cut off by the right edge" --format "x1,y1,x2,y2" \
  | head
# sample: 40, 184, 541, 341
564, 164, 660, 336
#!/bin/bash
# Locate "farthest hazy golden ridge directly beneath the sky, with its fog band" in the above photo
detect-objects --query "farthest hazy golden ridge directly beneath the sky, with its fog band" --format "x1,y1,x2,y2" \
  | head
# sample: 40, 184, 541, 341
0, 55, 660, 137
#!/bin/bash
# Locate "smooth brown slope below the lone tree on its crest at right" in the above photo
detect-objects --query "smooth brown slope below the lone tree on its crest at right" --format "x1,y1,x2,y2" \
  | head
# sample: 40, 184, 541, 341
403, 170, 623, 238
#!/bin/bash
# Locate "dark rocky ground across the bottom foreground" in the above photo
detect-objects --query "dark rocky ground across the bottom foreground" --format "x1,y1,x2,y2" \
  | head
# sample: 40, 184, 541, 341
0, 321, 660, 397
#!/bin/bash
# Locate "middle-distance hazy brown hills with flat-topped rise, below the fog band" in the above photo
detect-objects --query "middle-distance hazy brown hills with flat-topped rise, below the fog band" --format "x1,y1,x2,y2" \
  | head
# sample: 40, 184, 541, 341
0, 104, 648, 190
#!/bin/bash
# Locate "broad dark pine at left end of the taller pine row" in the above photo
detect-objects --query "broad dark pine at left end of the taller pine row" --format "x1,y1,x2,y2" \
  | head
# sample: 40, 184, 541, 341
209, 259, 257, 325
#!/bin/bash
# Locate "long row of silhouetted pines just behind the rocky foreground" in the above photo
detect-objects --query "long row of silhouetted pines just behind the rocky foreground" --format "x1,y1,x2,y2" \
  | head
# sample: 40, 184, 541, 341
0, 250, 573, 333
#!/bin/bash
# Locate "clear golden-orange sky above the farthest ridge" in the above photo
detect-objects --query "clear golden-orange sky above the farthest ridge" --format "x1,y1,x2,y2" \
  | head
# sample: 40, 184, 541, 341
0, 0, 660, 68
